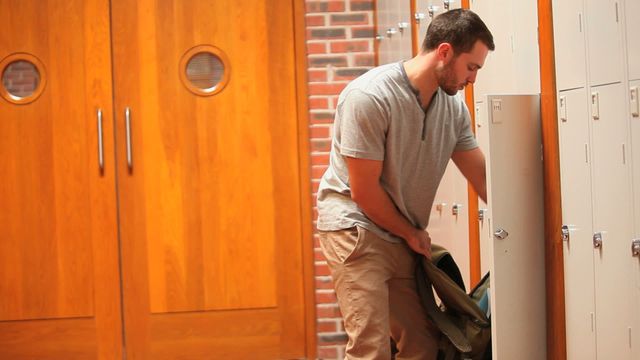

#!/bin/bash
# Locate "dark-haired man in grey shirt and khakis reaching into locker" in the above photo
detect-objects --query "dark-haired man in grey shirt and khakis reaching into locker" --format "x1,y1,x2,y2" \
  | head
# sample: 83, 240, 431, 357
317, 9, 495, 359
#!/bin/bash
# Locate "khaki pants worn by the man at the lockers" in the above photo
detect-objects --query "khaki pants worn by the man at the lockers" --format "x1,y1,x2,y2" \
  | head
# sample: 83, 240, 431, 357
320, 227, 440, 360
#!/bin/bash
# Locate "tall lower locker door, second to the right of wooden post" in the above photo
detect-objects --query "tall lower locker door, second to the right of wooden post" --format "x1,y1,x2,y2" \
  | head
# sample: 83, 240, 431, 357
590, 84, 634, 359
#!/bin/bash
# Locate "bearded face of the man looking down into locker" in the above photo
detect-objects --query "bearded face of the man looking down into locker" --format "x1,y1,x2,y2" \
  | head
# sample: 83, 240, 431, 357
436, 40, 489, 95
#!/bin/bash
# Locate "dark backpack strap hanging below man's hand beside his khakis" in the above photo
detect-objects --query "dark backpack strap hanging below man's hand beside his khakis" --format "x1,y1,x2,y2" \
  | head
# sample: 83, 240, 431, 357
415, 255, 471, 353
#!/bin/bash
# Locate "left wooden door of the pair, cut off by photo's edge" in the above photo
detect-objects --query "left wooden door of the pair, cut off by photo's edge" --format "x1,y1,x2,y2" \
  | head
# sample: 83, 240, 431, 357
0, 0, 122, 360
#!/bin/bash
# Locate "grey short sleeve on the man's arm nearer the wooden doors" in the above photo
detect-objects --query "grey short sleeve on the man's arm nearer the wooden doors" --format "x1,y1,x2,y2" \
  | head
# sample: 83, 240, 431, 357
338, 90, 388, 160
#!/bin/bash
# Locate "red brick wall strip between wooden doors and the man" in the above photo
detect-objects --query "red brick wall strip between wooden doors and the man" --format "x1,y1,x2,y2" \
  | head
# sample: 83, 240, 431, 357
306, 0, 375, 359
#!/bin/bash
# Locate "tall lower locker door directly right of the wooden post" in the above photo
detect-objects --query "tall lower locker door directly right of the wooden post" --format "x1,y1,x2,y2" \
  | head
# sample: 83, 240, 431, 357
558, 88, 596, 360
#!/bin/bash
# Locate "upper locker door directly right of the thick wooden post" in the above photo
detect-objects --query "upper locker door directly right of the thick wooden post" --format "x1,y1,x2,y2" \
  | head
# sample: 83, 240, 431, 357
552, 0, 587, 91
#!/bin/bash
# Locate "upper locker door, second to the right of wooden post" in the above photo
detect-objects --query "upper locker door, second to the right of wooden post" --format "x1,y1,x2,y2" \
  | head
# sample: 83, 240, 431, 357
586, 0, 624, 86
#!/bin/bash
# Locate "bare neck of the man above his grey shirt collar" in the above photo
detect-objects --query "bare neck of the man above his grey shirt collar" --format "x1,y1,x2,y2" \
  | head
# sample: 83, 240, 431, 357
403, 52, 438, 109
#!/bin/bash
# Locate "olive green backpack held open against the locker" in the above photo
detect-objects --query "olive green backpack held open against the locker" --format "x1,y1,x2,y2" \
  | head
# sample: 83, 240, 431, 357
416, 244, 491, 360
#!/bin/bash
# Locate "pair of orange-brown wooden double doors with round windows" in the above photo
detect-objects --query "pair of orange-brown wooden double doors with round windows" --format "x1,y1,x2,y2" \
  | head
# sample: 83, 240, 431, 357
0, 0, 311, 359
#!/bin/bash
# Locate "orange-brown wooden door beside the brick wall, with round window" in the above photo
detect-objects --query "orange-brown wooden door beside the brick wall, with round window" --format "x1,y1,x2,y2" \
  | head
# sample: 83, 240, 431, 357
111, 0, 313, 359
